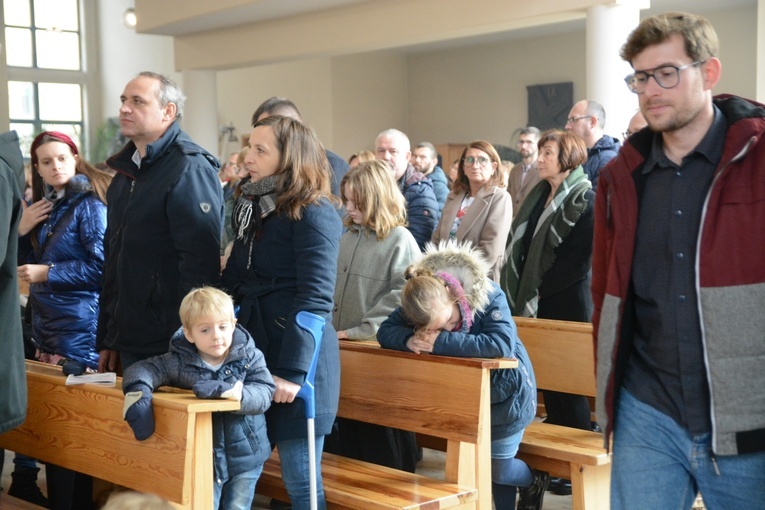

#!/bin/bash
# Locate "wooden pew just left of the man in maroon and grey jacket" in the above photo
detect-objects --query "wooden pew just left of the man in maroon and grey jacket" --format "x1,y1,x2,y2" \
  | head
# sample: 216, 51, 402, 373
515, 317, 611, 510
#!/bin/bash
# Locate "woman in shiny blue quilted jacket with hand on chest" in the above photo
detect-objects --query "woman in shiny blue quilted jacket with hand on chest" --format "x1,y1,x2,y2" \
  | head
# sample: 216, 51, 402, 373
14, 131, 111, 510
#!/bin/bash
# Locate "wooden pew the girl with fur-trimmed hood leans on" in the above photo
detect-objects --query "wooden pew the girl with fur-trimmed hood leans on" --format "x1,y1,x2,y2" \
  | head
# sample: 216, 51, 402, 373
257, 341, 517, 510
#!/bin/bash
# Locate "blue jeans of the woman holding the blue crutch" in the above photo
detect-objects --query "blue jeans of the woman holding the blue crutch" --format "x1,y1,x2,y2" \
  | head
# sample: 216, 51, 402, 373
276, 436, 327, 510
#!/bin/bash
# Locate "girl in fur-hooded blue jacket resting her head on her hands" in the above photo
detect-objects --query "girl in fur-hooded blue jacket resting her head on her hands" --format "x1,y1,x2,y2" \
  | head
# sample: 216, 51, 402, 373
377, 242, 549, 510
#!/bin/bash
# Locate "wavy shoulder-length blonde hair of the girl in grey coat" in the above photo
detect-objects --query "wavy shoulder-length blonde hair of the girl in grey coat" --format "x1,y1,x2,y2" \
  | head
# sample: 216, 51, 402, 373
340, 160, 406, 241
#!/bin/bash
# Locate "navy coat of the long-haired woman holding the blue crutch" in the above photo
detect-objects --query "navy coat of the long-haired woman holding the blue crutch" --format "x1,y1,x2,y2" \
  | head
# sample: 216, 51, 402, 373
222, 199, 342, 442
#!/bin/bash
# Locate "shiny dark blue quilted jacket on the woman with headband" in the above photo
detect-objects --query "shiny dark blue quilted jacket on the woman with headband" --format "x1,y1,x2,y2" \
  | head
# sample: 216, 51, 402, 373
19, 174, 106, 369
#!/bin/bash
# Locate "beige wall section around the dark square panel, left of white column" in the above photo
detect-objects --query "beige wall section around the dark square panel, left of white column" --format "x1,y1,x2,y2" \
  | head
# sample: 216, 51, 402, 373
409, 31, 585, 145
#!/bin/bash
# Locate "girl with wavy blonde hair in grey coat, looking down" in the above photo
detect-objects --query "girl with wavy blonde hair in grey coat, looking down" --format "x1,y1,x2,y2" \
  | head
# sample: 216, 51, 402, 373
333, 160, 420, 472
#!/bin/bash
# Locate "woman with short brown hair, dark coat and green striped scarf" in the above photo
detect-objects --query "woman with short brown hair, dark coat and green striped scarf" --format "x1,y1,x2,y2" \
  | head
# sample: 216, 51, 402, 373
500, 130, 595, 494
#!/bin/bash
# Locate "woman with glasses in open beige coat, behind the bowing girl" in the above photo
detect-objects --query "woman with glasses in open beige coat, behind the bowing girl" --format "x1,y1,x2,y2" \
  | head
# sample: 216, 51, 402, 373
430, 140, 513, 282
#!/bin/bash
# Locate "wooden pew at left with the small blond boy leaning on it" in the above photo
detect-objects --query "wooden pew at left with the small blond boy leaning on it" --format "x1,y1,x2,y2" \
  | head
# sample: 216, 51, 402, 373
0, 361, 239, 510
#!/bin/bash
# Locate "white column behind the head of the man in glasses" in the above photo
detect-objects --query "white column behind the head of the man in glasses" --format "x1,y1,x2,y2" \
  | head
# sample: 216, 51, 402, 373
574, 0, 644, 140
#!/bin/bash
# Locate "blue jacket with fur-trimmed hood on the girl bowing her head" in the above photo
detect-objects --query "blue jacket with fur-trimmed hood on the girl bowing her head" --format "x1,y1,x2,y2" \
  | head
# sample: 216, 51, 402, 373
377, 243, 537, 440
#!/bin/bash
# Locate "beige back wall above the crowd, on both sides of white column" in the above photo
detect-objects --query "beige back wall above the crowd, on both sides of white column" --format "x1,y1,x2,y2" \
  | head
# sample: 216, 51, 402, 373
212, 3, 757, 158
